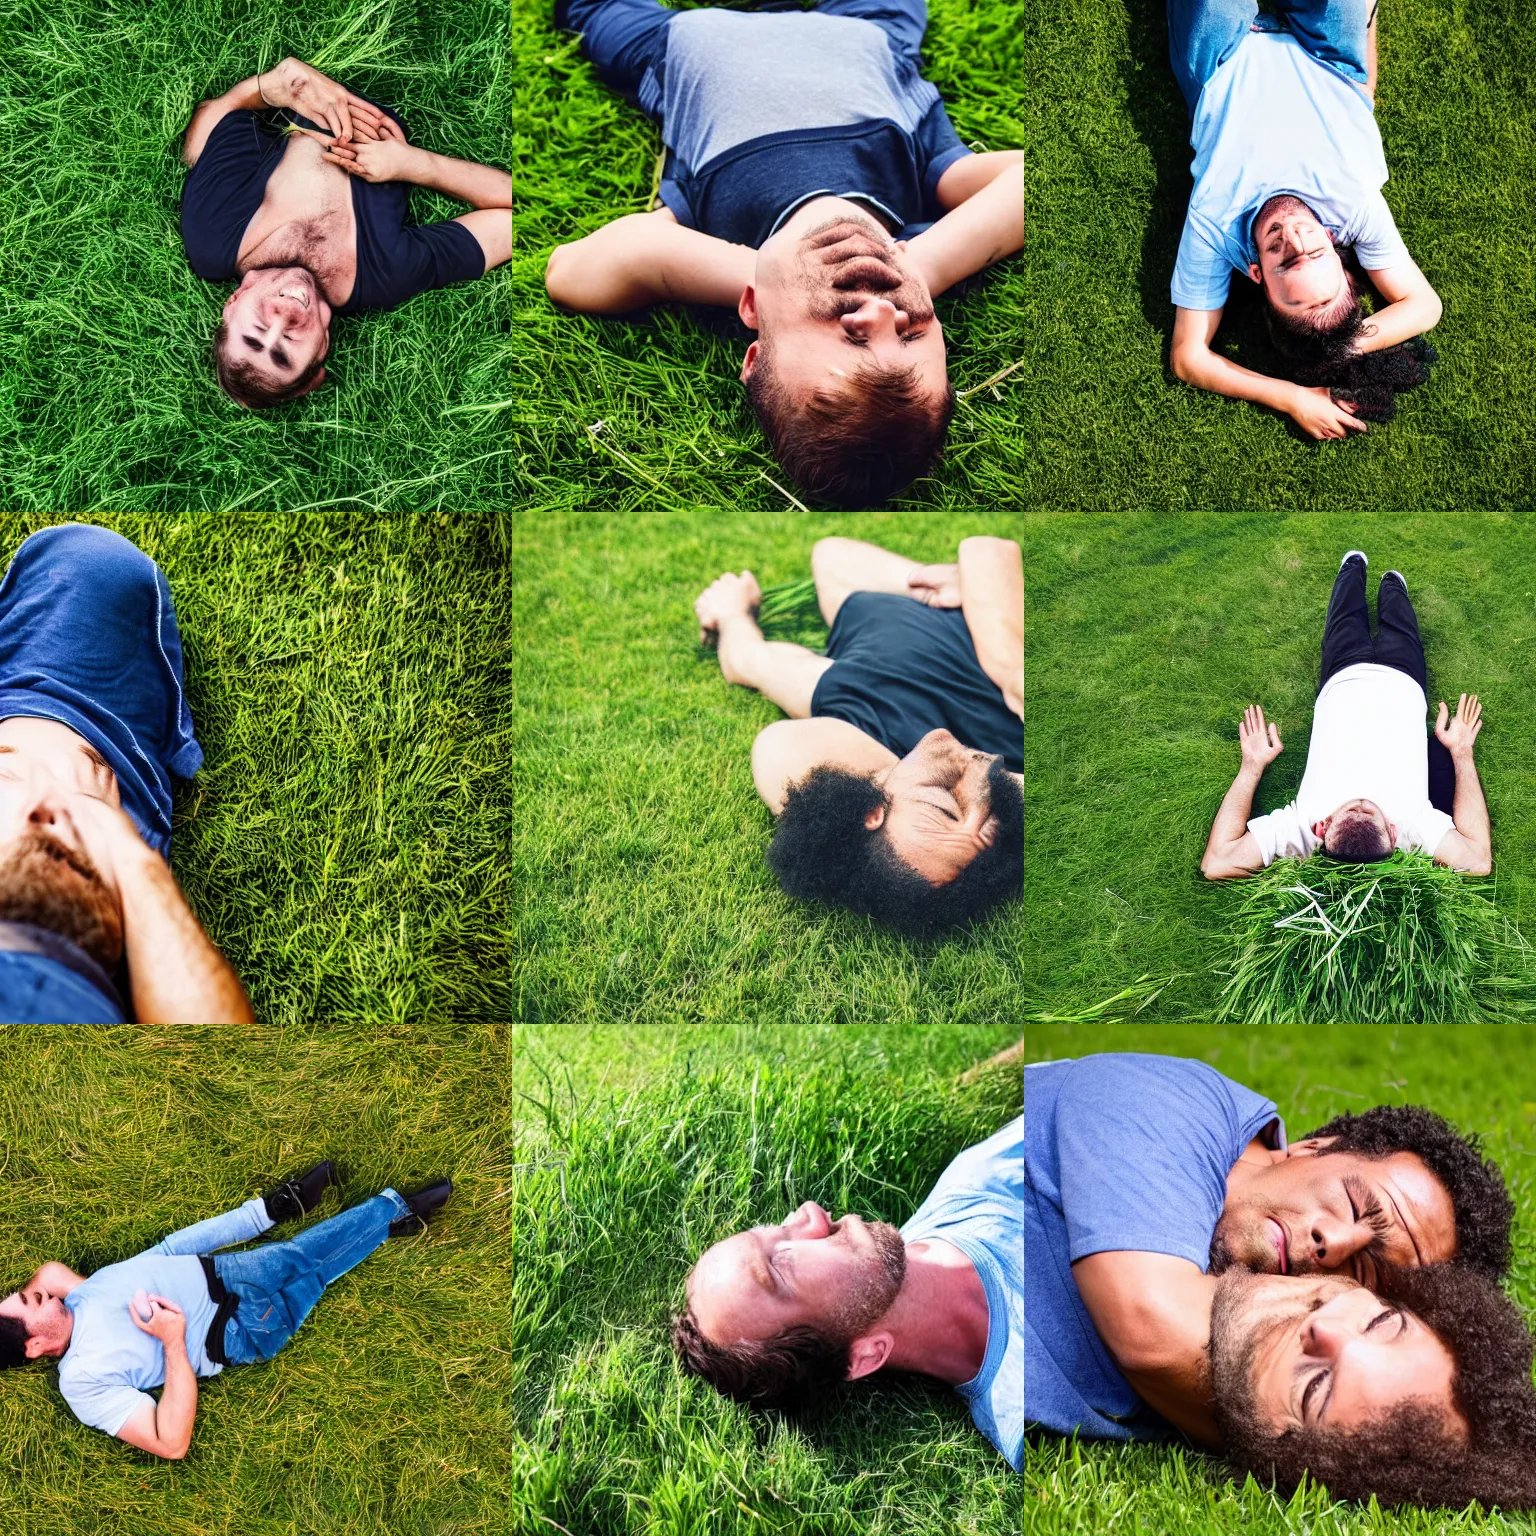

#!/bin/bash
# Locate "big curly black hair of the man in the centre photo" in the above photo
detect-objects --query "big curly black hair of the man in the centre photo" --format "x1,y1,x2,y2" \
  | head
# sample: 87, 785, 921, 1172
768, 760, 1025, 938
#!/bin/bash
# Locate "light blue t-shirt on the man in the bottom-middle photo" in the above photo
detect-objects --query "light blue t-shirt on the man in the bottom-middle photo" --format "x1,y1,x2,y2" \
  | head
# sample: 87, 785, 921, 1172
902, 1115, 1025, 1471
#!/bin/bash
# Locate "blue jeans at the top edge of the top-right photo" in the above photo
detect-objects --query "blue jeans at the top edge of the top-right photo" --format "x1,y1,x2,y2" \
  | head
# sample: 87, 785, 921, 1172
1167, 0, 1375, 112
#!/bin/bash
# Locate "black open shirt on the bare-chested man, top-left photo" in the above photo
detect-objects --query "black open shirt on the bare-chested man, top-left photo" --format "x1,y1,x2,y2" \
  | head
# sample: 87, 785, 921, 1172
181, 101, 485, 315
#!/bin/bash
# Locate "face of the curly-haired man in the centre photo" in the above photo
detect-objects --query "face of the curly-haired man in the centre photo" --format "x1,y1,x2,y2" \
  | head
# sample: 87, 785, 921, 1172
871, 730, 1023, 885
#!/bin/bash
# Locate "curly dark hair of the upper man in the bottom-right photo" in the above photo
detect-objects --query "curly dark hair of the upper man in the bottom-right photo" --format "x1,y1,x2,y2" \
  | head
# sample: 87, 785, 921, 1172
1303, 1104, 1514, 1281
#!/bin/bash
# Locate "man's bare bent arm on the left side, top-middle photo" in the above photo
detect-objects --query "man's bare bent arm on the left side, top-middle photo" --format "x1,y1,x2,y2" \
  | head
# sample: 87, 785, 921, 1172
544, 207, 757, 315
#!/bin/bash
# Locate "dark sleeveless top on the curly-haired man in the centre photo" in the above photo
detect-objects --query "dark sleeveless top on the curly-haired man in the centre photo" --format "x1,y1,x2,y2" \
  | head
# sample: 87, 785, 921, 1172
811, 591, 1025, 773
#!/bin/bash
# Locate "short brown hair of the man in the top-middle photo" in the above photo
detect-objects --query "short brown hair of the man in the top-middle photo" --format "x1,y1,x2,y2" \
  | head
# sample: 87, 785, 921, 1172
746, 350, 955, 508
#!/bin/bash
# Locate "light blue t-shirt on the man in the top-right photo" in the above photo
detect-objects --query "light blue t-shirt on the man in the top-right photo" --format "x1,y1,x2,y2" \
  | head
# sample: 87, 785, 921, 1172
1172, 31, 1410, 309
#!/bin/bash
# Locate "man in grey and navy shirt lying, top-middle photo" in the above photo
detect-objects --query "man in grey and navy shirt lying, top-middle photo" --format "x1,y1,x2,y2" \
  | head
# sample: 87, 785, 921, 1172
544, 0, 1025, 507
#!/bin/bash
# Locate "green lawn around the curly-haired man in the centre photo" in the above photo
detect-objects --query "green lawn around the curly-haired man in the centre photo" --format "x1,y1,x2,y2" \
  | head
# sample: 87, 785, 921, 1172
511, 513, 1023, 1026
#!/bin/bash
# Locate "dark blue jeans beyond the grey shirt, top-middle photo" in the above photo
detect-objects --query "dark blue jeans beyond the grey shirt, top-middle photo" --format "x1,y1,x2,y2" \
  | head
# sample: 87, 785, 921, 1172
554, 0, 928, 121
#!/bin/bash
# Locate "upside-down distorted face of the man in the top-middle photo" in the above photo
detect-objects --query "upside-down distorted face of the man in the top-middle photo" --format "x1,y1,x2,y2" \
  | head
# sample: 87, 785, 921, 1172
740, 207, 949, 406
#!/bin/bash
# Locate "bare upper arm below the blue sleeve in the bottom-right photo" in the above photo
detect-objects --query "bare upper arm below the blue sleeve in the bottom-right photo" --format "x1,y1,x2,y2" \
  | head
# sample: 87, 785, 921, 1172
1072, 1252, 1221, 1447
